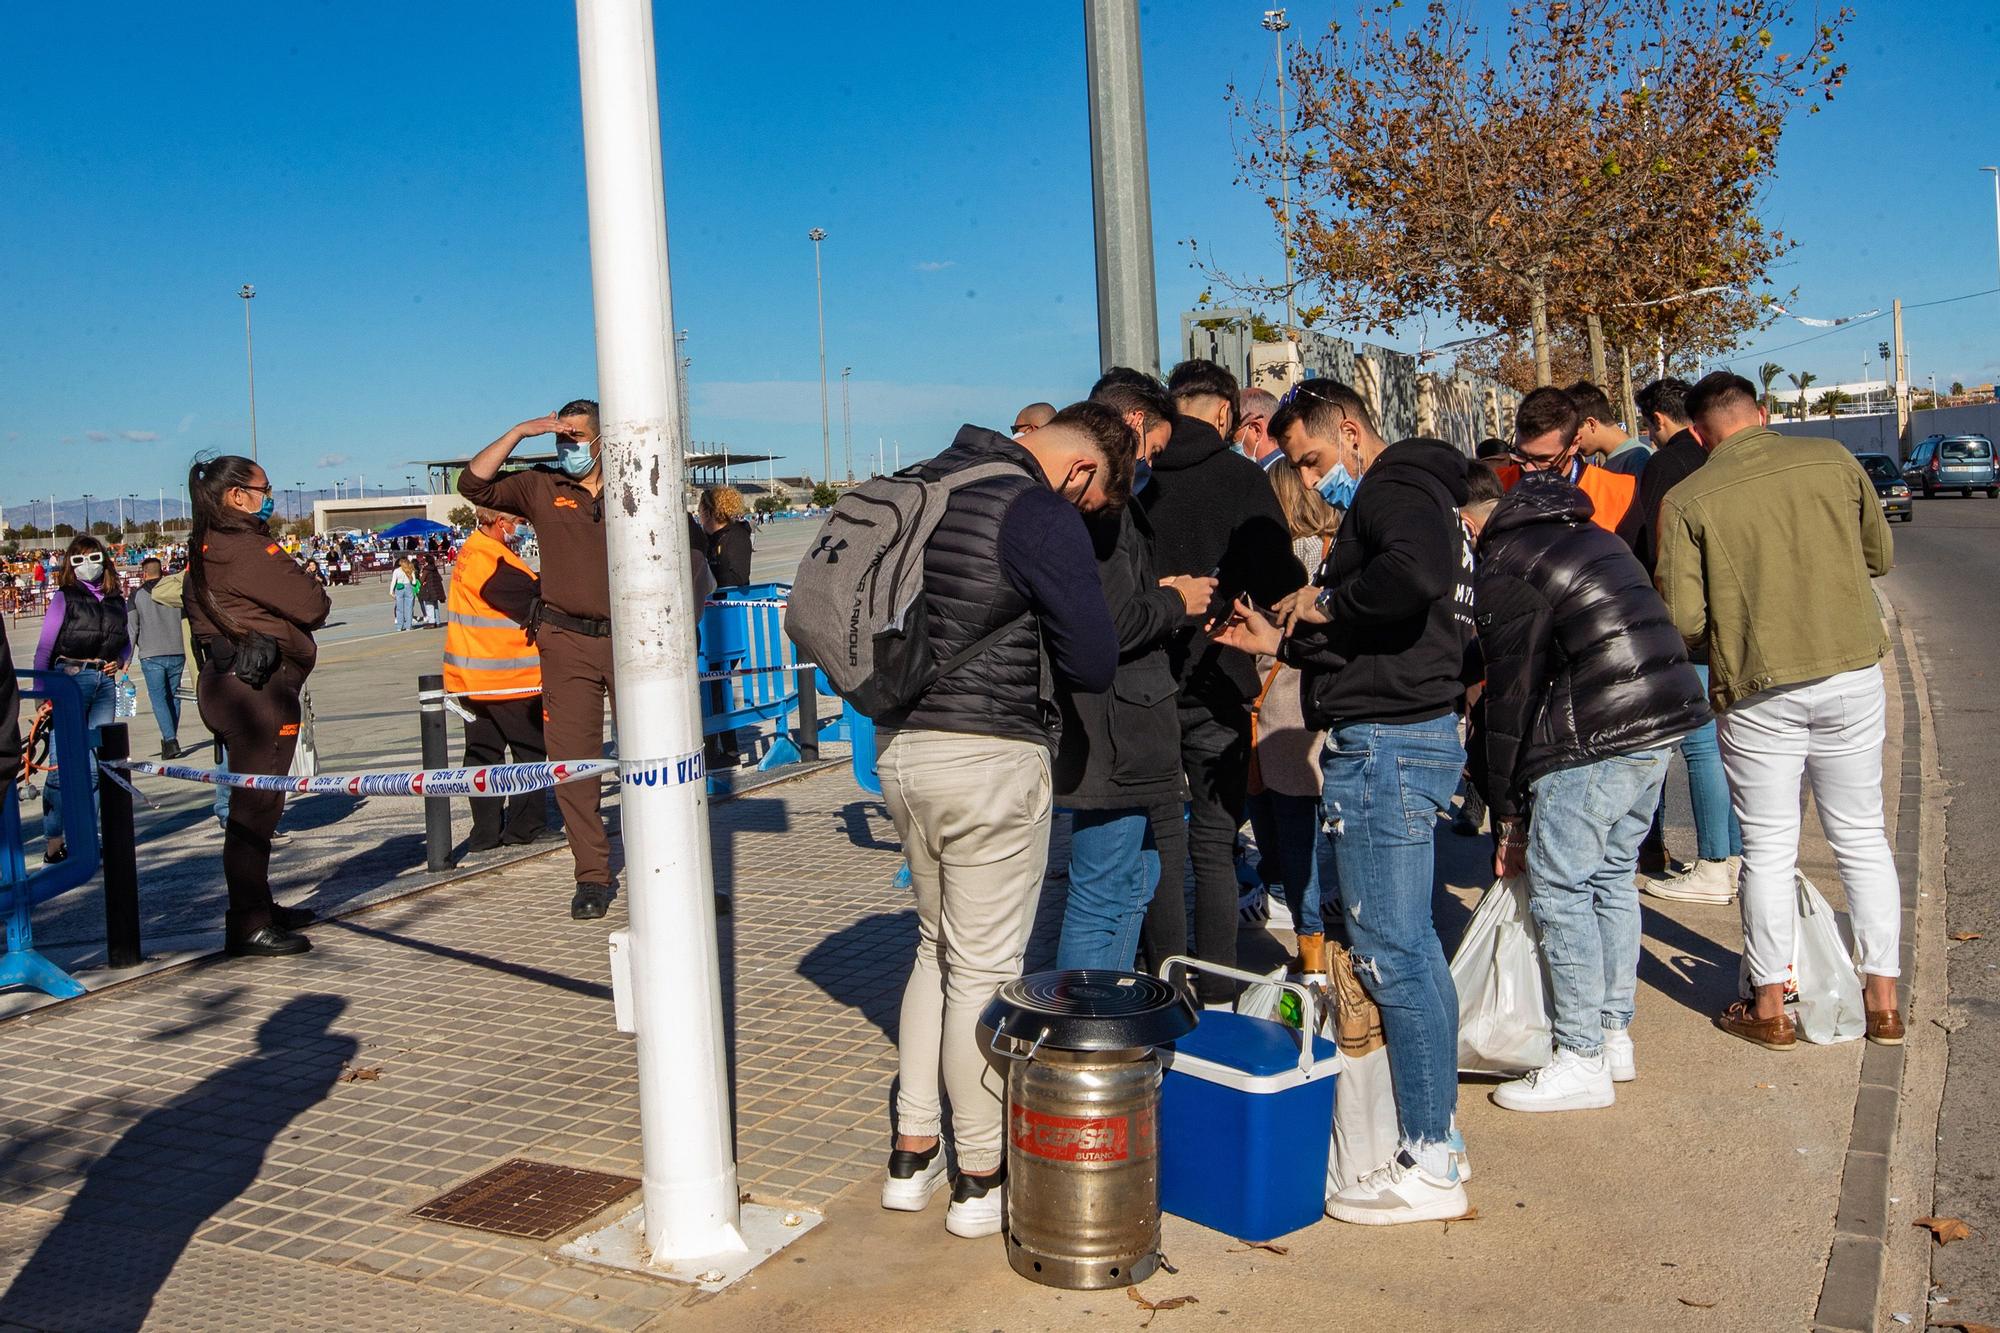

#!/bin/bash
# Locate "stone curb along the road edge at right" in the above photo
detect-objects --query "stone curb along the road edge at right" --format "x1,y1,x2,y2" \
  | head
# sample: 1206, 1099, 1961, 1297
1812, 598, 1924, 1333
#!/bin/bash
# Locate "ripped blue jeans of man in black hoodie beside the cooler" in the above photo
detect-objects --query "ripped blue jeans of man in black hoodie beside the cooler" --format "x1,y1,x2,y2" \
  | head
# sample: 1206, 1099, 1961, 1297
1320, 713, 1466, 1161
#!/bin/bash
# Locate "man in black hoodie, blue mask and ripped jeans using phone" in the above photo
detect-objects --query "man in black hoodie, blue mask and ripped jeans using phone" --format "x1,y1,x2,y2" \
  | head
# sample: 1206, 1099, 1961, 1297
1218, 380, 1472, 1225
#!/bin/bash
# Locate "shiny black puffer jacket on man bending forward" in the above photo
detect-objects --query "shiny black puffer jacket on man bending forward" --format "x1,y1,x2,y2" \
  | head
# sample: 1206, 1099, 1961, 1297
1474, 472, 1710, 817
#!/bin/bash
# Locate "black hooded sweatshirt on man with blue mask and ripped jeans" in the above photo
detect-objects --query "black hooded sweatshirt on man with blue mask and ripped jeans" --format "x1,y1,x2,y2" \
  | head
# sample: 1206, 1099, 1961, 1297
1278, 438, 1472, 731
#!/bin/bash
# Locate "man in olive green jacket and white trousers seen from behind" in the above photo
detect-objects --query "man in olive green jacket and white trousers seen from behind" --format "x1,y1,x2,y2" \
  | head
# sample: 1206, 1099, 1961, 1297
1658, 370, 1904, 1051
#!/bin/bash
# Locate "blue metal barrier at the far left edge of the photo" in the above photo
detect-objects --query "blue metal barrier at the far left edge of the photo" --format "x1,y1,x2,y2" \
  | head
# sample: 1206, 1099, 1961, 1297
0, 671, 98, 999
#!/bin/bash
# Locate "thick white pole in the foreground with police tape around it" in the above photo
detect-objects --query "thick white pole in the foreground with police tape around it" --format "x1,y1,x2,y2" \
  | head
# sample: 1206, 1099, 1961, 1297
576, 0, 772, 1281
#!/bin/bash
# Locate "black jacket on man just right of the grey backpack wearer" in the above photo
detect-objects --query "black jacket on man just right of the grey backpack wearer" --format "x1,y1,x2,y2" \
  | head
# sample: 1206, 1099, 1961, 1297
1054, 504, 1190, 817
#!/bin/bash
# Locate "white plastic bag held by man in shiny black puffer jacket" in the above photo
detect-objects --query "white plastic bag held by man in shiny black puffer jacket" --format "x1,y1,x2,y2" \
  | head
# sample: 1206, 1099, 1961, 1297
1452, 877, 1554, 1075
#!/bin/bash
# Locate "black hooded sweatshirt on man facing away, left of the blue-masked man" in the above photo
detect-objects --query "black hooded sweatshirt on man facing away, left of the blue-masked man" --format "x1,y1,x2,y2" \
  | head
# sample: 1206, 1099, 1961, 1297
1134, 416, 1306, 727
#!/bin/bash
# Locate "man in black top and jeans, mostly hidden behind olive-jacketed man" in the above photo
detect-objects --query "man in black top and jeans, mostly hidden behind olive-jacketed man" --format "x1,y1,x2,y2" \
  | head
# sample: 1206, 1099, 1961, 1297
1638, 380, 1744, 892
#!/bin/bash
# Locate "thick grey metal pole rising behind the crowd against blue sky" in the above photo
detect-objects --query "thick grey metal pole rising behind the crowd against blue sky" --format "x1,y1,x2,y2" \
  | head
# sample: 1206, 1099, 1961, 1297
1084, 0, 1160, 374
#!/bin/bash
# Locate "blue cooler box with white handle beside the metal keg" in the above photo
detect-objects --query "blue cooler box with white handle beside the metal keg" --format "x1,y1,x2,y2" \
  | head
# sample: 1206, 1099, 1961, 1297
1160, 1000, 1336, 1241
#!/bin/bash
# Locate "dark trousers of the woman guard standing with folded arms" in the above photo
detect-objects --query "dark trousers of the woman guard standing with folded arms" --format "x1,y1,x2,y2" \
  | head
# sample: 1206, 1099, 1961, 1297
194, 662, 306, 939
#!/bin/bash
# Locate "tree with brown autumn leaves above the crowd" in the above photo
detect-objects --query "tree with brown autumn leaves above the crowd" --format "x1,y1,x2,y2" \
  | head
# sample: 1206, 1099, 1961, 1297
1232, 0, 1850, 384
